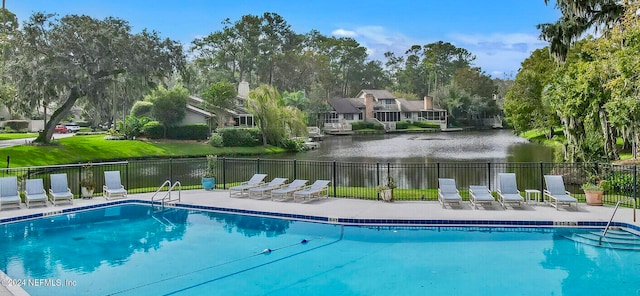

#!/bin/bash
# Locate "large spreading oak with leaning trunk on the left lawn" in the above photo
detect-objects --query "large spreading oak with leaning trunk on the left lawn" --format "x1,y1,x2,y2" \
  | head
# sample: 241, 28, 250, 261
5, 13, 184, 143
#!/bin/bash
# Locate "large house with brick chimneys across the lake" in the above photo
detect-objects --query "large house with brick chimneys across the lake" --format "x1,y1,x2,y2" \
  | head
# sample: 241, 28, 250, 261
324, 89, 447, 133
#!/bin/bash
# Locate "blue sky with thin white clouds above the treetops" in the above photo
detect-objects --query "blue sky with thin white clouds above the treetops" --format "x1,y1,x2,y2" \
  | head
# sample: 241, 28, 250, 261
6, 0, 560, 78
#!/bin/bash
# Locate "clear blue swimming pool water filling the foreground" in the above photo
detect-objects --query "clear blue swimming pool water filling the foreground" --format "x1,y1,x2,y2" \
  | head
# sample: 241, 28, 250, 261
0, 204, 640, 295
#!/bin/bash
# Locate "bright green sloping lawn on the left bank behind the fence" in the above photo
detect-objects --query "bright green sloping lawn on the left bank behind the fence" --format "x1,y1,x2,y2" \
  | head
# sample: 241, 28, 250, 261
0, 135, 284, 167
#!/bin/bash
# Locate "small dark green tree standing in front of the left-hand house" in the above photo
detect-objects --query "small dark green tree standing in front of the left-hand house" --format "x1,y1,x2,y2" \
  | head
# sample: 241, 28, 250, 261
202, 80, 238, 126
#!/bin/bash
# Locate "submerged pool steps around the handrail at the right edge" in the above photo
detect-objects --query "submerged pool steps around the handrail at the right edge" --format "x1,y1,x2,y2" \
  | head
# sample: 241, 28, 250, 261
564, 229, 640, 251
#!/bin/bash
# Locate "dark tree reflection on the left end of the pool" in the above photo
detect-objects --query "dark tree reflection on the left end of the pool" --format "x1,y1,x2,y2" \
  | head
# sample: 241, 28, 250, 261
0, 205, 188, 278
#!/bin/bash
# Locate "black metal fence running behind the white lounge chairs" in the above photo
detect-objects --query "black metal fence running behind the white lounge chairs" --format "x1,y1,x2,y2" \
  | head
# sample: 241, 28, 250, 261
0, 157, 638, 205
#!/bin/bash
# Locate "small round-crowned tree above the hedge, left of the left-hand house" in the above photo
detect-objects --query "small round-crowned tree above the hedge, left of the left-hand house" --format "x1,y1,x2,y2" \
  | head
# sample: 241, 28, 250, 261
145, 85, 189, 137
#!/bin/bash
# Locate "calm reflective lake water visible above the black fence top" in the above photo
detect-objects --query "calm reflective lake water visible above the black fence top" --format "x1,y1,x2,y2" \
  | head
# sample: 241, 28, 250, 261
265, 130, 553, 163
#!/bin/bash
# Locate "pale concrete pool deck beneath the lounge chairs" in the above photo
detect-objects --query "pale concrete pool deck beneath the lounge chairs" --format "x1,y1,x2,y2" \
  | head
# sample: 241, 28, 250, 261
0, 189, 640, 296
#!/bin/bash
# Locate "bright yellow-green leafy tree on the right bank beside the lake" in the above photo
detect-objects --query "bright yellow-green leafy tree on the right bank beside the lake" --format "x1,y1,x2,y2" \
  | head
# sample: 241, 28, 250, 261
542, 38, 617, 161
